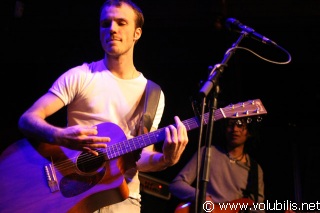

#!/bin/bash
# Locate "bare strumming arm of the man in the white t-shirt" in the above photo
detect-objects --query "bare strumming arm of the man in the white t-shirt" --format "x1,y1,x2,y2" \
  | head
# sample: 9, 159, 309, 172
18, 92, 110, 155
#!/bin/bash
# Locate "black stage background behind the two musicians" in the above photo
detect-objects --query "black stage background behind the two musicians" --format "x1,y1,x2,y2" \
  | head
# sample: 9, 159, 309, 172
0, 0, 320, 212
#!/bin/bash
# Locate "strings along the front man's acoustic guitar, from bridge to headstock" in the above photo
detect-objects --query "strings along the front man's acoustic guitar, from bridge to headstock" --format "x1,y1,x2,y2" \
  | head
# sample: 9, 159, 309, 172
54, 101, 261, 170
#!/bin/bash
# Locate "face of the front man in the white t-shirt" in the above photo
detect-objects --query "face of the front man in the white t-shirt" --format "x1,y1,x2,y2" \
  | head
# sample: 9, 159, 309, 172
100, 3, 142, 57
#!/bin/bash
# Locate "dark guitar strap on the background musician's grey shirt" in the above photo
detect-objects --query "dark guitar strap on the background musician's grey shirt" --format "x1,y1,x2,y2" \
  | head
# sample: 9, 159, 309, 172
243, 156, 259, 202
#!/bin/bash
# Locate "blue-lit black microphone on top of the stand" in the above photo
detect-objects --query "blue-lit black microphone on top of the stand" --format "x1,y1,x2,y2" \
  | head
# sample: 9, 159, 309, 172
226, 18, 278, 46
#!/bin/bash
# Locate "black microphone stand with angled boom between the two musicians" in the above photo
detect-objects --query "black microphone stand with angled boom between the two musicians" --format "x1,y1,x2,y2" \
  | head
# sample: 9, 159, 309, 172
195, 31, 247, 213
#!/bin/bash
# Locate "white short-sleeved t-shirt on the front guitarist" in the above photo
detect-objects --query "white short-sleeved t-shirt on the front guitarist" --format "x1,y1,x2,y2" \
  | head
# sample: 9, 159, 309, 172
49, 60, 165, 199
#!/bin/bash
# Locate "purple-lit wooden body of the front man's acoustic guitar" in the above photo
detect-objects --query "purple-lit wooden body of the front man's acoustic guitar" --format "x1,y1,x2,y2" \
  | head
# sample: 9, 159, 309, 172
0, 123, 128, 213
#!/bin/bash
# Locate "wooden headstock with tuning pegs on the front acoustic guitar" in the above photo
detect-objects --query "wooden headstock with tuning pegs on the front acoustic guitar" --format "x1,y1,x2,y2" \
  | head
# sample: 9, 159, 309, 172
220, 99, 267, 118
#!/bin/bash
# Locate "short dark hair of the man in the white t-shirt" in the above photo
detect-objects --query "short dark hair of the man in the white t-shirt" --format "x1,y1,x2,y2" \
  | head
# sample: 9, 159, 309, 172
100, 0, 144, 28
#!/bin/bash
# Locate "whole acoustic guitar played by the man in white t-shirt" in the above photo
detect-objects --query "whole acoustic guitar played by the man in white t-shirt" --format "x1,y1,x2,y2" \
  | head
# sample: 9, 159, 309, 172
0, 99, 267, 213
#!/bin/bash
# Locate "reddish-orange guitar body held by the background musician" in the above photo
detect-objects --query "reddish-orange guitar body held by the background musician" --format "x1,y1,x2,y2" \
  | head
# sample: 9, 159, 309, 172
174, 198, 253, 213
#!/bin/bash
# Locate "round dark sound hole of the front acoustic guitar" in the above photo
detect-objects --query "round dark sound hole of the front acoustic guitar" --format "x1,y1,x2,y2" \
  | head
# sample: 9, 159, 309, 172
77, 150, 105, 172
